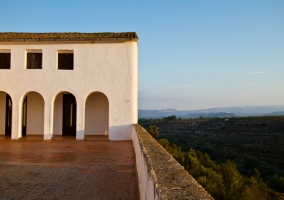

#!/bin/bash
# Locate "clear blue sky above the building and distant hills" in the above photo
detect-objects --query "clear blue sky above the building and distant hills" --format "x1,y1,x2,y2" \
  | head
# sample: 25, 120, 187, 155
0, 0, 284, 110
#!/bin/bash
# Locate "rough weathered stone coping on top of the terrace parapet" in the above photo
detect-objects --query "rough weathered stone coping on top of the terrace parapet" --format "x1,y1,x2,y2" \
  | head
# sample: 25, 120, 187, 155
133, 124, 213, 200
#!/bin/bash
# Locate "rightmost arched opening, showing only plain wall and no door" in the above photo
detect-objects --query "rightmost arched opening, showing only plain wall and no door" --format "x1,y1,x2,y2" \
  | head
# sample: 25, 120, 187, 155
85, 92, 109, 135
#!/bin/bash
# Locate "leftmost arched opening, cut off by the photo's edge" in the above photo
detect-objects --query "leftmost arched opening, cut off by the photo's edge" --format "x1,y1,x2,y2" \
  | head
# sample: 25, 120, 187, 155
0, 91, 13, 136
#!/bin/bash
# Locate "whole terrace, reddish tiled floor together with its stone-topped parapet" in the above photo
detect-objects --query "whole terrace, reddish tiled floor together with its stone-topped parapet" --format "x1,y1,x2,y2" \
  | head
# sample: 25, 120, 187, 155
0, 125, 213, 200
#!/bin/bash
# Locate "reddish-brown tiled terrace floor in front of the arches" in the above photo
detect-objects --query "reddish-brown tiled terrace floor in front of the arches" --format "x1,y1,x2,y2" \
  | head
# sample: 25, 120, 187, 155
0, 138, 139, 200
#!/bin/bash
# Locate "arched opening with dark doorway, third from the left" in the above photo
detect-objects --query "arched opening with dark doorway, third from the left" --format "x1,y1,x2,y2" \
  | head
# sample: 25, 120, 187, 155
53, 92, 77, 136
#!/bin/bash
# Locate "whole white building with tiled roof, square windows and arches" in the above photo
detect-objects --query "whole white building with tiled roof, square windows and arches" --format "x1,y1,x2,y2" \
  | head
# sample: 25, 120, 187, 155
0, 32, 138, 140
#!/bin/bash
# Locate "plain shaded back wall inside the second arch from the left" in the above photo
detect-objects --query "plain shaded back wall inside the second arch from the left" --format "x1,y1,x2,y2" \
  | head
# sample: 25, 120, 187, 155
27, 92, 44, 135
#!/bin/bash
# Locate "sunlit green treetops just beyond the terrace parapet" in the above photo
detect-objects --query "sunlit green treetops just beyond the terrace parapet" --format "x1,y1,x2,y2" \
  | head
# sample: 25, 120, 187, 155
158, 139, 276, 200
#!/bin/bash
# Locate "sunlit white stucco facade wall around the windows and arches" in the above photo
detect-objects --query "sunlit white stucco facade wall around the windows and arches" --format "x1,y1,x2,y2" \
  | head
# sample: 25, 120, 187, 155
0, 42, 138, 140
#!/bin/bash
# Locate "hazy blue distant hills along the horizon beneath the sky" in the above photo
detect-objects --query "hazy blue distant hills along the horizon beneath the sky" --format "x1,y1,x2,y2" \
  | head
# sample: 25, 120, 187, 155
138, 105, 284, 119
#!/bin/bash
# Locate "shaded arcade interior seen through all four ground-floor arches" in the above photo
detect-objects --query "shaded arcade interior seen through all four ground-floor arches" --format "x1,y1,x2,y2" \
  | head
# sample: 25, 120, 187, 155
0, 91, 109, 139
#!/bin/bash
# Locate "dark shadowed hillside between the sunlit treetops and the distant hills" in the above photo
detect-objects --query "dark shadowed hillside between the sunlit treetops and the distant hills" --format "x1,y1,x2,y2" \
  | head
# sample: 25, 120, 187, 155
139, 116, 284, 197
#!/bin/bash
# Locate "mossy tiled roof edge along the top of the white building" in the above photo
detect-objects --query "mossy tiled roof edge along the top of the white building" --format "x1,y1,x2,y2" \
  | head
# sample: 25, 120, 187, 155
0, 32, 138, 42
